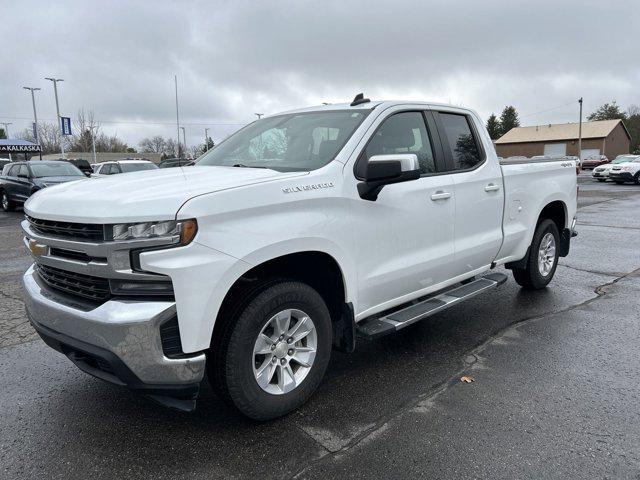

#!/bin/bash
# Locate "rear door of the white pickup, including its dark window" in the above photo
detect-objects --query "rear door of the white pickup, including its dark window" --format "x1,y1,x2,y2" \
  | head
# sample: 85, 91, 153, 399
434, 110, 504, 276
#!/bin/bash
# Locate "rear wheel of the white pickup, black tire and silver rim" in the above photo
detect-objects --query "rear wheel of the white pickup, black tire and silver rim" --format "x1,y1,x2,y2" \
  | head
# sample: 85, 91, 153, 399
513, 219, 560, 290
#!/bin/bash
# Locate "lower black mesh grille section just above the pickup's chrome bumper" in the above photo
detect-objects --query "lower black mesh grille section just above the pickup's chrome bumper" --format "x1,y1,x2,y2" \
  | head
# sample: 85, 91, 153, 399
36, 265, 111, 302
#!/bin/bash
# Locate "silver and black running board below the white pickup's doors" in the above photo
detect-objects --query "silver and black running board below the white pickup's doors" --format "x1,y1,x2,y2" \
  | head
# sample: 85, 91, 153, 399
357, 273, 507, 338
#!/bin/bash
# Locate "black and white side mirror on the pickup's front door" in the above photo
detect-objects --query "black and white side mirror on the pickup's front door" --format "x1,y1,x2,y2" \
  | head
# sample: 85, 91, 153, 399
358, 153, 420, 201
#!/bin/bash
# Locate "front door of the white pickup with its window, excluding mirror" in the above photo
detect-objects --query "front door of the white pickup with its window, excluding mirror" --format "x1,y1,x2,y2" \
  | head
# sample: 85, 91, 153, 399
353, 111, 456, 316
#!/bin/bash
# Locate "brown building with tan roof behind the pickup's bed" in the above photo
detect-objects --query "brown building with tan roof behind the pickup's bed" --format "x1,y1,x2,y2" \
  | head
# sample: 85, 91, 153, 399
495, 120, 631, 159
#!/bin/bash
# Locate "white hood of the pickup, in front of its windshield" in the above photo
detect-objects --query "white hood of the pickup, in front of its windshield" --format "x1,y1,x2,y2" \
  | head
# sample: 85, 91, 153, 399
24, 166, 307, 223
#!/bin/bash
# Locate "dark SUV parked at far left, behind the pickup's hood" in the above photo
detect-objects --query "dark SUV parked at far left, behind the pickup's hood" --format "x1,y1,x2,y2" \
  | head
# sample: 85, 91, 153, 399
0, 160, 86, 212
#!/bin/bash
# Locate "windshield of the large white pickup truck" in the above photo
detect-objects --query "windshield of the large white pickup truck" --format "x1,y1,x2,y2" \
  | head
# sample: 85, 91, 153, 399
196, 110, 370, 172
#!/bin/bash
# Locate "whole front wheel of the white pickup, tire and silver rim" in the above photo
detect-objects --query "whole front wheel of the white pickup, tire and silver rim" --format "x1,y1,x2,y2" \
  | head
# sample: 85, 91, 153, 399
208, 281, 332, 420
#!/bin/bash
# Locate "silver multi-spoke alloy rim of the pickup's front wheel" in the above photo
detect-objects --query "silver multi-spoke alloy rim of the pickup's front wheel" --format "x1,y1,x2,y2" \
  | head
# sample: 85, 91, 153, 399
253, 309, 318, 395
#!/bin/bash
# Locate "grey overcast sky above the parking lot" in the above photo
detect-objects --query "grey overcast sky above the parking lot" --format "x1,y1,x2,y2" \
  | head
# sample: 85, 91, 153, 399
0, 0, 640, 145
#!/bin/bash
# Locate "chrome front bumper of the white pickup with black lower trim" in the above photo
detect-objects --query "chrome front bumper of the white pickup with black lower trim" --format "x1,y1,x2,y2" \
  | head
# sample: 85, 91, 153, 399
23, 266, 205, 410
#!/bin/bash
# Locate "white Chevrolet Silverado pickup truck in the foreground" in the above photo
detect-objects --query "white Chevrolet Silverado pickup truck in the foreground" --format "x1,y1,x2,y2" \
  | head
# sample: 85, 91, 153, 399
22, 95, 577, 420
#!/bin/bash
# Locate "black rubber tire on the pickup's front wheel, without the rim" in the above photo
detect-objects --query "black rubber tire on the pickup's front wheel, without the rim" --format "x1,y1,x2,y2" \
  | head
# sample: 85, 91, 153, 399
207, 280, 332, 421
